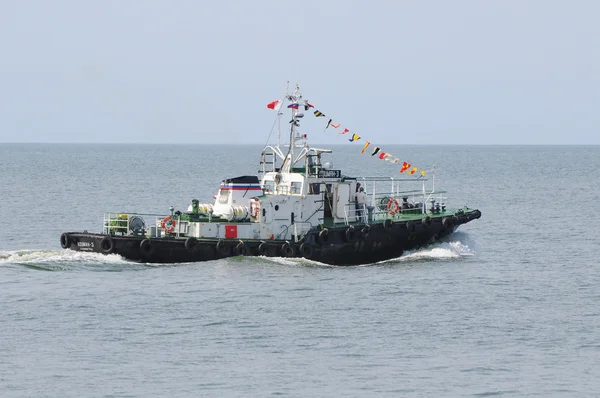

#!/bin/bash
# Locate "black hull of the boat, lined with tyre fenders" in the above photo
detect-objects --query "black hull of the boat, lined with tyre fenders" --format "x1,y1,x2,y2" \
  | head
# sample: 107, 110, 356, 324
61, 210, 481, 265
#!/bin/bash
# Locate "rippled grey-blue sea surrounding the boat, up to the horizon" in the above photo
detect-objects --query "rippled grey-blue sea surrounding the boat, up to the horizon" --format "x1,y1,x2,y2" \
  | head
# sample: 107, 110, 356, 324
0, 144, 600, 397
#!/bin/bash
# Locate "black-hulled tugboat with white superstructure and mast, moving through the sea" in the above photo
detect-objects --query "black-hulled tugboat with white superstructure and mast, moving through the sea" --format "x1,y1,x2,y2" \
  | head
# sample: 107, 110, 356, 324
60, 87, 481, 265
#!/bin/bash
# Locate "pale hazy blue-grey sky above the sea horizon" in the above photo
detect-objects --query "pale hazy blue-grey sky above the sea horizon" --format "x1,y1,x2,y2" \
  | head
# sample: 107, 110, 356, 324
0, 0, 600, 144
